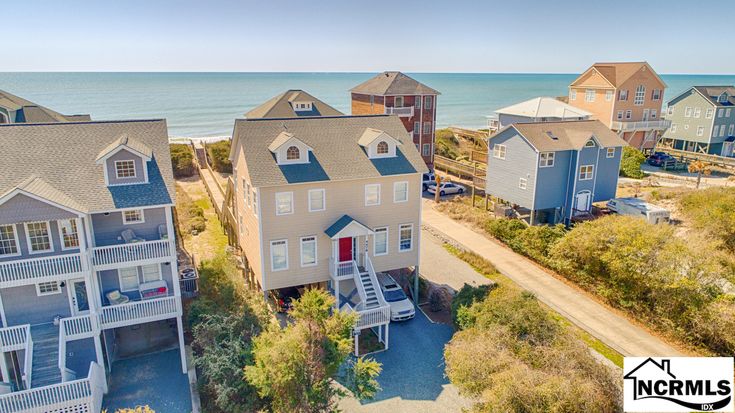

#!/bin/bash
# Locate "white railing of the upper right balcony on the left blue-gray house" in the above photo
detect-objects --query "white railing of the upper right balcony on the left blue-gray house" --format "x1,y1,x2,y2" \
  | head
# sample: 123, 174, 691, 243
92, 240, 174, 270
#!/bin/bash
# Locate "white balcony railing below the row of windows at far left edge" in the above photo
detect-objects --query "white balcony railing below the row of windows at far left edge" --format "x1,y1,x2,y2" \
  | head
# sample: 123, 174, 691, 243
0, 254, 86, 288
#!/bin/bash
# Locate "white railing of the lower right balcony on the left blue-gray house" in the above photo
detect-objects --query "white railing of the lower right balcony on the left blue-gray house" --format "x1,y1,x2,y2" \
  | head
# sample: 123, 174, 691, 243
99, 296, 181, 329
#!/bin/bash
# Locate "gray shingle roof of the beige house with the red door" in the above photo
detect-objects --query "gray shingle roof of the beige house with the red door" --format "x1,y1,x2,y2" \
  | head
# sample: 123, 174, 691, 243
233, 115, 427, 187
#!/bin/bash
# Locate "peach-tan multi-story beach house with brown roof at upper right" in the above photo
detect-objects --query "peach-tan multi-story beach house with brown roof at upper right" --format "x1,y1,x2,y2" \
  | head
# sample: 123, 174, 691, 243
569, 62, 670, 149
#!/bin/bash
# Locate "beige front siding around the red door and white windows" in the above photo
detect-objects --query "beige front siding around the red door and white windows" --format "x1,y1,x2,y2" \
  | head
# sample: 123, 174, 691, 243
255, 174, 421, 290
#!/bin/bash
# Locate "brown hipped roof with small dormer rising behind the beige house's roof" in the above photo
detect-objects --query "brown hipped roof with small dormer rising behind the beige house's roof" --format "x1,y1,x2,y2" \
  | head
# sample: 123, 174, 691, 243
245, 89, 344, 119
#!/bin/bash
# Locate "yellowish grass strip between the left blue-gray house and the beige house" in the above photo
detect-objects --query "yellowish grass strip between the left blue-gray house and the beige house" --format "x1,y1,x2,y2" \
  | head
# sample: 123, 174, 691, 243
176, 176, 227, 261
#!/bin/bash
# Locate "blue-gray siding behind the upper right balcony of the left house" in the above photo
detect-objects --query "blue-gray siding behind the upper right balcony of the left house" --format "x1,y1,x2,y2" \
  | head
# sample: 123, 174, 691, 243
92, 207, 166, 247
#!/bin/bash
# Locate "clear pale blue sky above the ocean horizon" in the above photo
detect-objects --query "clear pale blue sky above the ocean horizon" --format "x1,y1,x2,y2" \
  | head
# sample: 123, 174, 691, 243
0, 0, 735, 74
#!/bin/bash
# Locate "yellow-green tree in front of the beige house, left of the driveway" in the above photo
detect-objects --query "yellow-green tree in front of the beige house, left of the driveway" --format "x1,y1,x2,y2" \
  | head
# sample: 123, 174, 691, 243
245, 290, 380, 413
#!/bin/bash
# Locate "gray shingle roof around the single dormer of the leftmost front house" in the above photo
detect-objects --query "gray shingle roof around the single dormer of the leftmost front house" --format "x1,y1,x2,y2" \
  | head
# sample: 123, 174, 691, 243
0, 120, 175, 212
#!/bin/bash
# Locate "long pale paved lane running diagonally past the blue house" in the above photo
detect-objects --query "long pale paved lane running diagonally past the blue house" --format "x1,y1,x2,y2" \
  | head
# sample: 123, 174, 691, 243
422, 200, 683, 356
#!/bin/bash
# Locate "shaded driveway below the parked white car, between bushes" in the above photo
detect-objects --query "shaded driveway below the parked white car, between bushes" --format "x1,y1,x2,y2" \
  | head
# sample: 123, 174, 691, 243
340, 311, 470, 413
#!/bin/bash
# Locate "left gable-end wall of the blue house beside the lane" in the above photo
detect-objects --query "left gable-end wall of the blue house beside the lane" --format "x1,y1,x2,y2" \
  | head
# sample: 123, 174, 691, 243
486, 128, 537, 209
